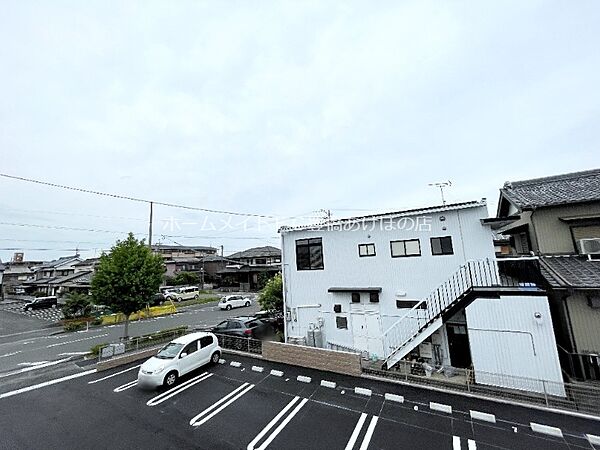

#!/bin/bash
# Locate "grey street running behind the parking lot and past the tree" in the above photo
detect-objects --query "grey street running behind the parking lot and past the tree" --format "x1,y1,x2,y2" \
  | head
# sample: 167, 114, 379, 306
0, 302, 260, 374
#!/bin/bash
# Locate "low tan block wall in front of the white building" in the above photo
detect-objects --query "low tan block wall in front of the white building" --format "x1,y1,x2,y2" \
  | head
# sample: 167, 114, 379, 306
262, 342, 362, 375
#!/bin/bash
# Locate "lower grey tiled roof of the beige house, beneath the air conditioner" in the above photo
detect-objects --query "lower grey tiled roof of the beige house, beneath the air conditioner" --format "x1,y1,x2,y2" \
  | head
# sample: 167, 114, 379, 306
540, 256, 600, 289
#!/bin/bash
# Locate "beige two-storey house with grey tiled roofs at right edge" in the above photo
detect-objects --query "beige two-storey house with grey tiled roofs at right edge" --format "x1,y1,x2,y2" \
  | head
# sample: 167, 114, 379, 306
487, 169, 600, 380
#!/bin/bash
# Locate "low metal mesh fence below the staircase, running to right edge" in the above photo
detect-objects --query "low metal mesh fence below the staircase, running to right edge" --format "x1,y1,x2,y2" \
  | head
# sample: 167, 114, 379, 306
363, 361, 600, 415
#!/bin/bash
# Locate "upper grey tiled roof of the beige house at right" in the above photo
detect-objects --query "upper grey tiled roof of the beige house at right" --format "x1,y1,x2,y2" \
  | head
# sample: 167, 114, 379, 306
500, 169, 600, 209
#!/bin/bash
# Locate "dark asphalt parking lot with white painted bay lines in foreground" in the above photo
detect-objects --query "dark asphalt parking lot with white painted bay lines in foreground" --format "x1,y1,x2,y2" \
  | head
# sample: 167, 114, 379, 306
0, 355, 600, 450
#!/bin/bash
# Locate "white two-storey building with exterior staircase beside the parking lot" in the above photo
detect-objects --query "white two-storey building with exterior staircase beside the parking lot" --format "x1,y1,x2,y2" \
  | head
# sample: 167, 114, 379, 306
280, 199, 564, 395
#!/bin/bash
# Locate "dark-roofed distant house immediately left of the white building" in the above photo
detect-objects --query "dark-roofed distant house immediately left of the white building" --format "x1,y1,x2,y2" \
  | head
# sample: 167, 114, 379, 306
217, 246, 281, 291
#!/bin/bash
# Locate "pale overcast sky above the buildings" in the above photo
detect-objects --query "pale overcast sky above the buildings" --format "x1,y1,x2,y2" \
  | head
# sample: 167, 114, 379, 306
0, 0, 600, 261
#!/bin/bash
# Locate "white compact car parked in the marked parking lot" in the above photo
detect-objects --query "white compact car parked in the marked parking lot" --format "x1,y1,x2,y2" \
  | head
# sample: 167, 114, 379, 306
137, 332, 221, 388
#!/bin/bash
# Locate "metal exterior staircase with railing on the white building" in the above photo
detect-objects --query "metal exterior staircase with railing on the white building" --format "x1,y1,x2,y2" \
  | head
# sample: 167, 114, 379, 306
383, 259, 505, 369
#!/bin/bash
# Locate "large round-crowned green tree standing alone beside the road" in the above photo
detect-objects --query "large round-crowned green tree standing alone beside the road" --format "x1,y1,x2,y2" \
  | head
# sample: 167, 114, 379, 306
92, 233, 164, 337
